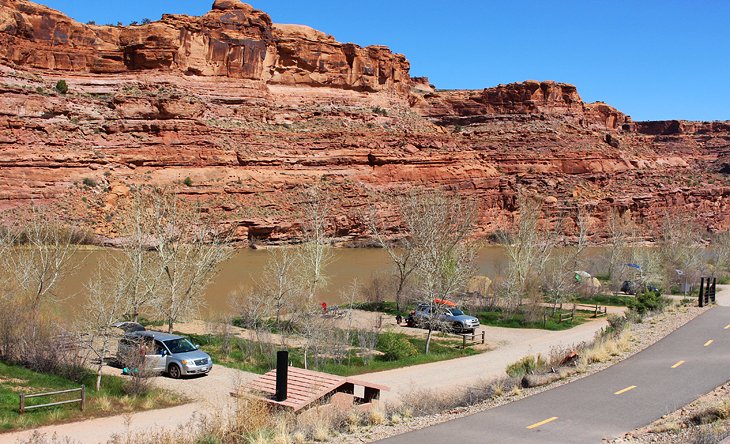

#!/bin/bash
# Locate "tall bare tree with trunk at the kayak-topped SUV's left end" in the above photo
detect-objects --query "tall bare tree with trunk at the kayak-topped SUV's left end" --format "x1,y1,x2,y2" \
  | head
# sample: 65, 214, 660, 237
399, 191, 477, 353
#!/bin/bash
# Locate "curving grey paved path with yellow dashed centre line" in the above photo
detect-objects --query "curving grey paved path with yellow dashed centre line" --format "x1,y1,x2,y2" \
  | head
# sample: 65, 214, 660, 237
382, 307, 730, 444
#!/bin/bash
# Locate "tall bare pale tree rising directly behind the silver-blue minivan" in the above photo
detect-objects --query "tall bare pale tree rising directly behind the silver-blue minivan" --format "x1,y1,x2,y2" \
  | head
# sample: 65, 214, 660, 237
153, 192, 230, 332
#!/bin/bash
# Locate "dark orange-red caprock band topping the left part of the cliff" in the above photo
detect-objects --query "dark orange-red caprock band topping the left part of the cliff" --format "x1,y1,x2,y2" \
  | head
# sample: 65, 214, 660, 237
0, 0, 410, 91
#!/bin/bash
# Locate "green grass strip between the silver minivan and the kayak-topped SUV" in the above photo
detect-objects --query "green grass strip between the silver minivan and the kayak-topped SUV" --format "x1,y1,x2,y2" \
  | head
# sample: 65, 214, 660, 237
186, 333, 479, 376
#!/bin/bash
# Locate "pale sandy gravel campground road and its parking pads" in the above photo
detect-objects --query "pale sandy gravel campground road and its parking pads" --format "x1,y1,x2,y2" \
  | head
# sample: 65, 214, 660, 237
7, 291, 716, 444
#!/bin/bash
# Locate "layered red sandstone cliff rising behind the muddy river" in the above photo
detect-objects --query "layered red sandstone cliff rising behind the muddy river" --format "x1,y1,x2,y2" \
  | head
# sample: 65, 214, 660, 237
0, 0, 730, 241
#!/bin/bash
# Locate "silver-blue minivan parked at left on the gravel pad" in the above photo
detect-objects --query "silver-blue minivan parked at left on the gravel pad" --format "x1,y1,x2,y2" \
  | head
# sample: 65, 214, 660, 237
114, 322, 213, 379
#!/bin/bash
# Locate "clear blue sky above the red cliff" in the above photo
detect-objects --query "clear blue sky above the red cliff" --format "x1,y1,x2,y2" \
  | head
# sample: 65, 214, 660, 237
35, 0, 730, 120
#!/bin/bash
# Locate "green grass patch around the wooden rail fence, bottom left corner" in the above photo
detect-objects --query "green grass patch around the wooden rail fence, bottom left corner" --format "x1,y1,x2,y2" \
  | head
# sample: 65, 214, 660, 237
0, 362, 184, 432
